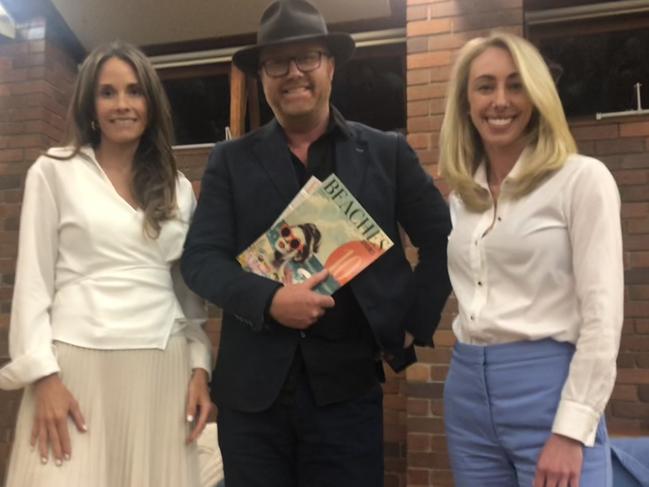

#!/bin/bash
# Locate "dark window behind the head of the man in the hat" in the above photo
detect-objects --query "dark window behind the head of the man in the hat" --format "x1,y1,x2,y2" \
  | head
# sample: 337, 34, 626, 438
152, 29, 406, 145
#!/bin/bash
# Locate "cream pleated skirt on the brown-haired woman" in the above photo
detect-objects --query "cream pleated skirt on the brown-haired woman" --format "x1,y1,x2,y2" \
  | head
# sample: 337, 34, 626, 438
6, 335, 199, 487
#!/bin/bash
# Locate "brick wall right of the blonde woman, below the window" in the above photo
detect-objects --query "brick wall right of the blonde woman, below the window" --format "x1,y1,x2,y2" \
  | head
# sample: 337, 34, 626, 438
571, 120, 649, 435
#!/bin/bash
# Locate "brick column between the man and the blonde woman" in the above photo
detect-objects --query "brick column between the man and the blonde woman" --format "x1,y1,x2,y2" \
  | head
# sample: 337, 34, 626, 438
405, 0, 523, 487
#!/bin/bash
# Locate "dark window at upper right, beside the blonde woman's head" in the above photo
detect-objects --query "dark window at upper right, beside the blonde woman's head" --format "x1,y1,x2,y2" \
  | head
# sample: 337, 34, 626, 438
525, 0, 649, 117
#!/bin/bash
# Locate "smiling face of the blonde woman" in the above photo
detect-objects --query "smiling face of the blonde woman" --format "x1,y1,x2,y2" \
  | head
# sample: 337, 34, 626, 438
467, 47, 534, 153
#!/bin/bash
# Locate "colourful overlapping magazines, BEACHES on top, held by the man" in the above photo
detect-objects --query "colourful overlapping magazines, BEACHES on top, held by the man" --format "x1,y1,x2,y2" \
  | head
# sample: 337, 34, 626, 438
237, 174, 394, 294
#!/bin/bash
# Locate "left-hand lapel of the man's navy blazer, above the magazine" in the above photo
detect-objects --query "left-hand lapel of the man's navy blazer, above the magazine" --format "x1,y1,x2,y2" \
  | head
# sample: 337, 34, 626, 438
252, 120, 300, 204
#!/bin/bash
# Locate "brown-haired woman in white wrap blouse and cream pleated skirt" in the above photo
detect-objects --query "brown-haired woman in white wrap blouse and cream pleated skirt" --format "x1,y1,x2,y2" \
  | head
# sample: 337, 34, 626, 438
0, 42, 212, 487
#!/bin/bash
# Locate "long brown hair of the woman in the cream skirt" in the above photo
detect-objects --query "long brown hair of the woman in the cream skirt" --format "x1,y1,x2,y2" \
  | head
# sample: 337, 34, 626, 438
48, 41, 177, 238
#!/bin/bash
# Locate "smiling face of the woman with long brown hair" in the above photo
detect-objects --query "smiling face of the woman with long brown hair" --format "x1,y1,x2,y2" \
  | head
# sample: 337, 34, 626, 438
95, 57, 147, 151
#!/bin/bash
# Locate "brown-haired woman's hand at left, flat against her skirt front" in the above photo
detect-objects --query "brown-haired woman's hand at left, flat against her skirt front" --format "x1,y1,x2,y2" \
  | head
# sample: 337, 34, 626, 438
30, 374, 87, 466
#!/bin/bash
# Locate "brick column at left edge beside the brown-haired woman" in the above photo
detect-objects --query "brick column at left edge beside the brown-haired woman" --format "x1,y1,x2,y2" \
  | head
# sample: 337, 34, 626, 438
0, 18, 76, 482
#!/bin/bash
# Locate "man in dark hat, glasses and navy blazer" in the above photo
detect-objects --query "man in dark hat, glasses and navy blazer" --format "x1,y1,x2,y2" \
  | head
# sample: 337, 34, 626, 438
182, 0, 450, 487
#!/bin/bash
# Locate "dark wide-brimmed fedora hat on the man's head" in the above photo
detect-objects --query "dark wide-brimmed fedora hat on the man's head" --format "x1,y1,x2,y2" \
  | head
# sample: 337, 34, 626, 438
232, 0, 355, 76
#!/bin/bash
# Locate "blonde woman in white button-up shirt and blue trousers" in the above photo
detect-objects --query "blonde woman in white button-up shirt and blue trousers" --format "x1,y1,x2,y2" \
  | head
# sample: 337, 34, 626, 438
440, 32, 623, 487
